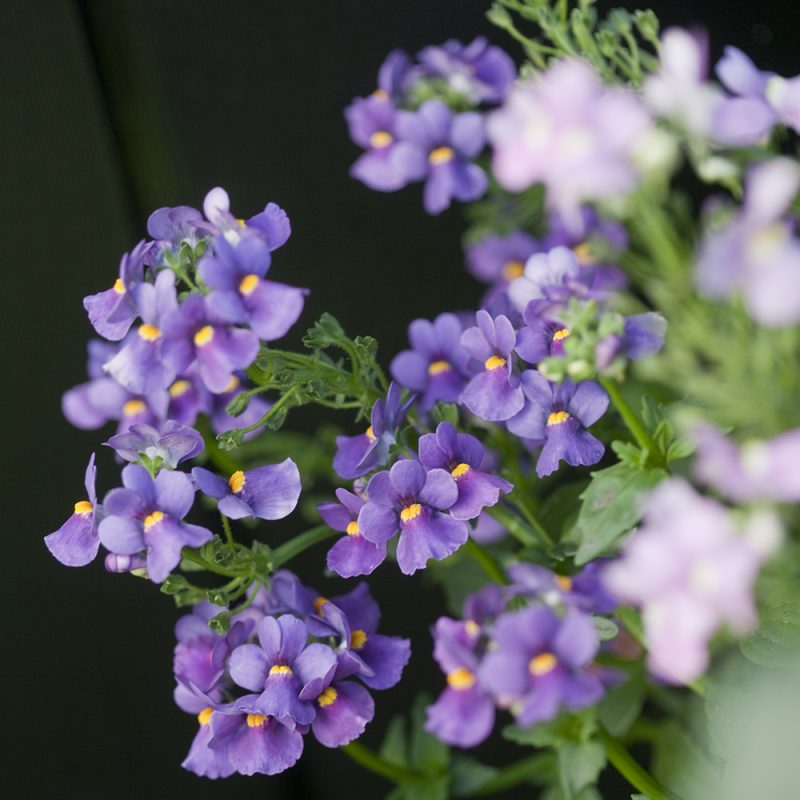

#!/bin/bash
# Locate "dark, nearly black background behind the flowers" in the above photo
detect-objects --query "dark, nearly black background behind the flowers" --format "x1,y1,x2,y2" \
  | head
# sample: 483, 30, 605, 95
0, 0, 800, 800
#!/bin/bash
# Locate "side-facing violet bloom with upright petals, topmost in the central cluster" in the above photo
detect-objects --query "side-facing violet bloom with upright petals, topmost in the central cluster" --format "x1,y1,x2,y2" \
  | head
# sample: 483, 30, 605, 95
333, 382, 414, 480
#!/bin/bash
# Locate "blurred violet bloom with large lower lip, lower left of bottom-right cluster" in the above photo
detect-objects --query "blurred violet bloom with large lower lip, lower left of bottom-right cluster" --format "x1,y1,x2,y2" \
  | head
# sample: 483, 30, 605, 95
425, 617, 494, 747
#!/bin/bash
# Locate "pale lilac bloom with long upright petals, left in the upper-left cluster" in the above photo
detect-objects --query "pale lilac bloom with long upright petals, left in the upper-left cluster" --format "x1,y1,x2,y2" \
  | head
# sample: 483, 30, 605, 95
103, 270, 178, 394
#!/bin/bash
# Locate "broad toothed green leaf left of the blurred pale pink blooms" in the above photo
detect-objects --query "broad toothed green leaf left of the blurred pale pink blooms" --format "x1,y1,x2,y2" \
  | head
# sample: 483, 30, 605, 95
575, 464, 667, 566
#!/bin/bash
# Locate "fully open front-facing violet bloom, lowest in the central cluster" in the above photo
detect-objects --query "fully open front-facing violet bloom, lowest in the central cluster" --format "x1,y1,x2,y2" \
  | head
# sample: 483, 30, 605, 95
358, 461, 469, 575
